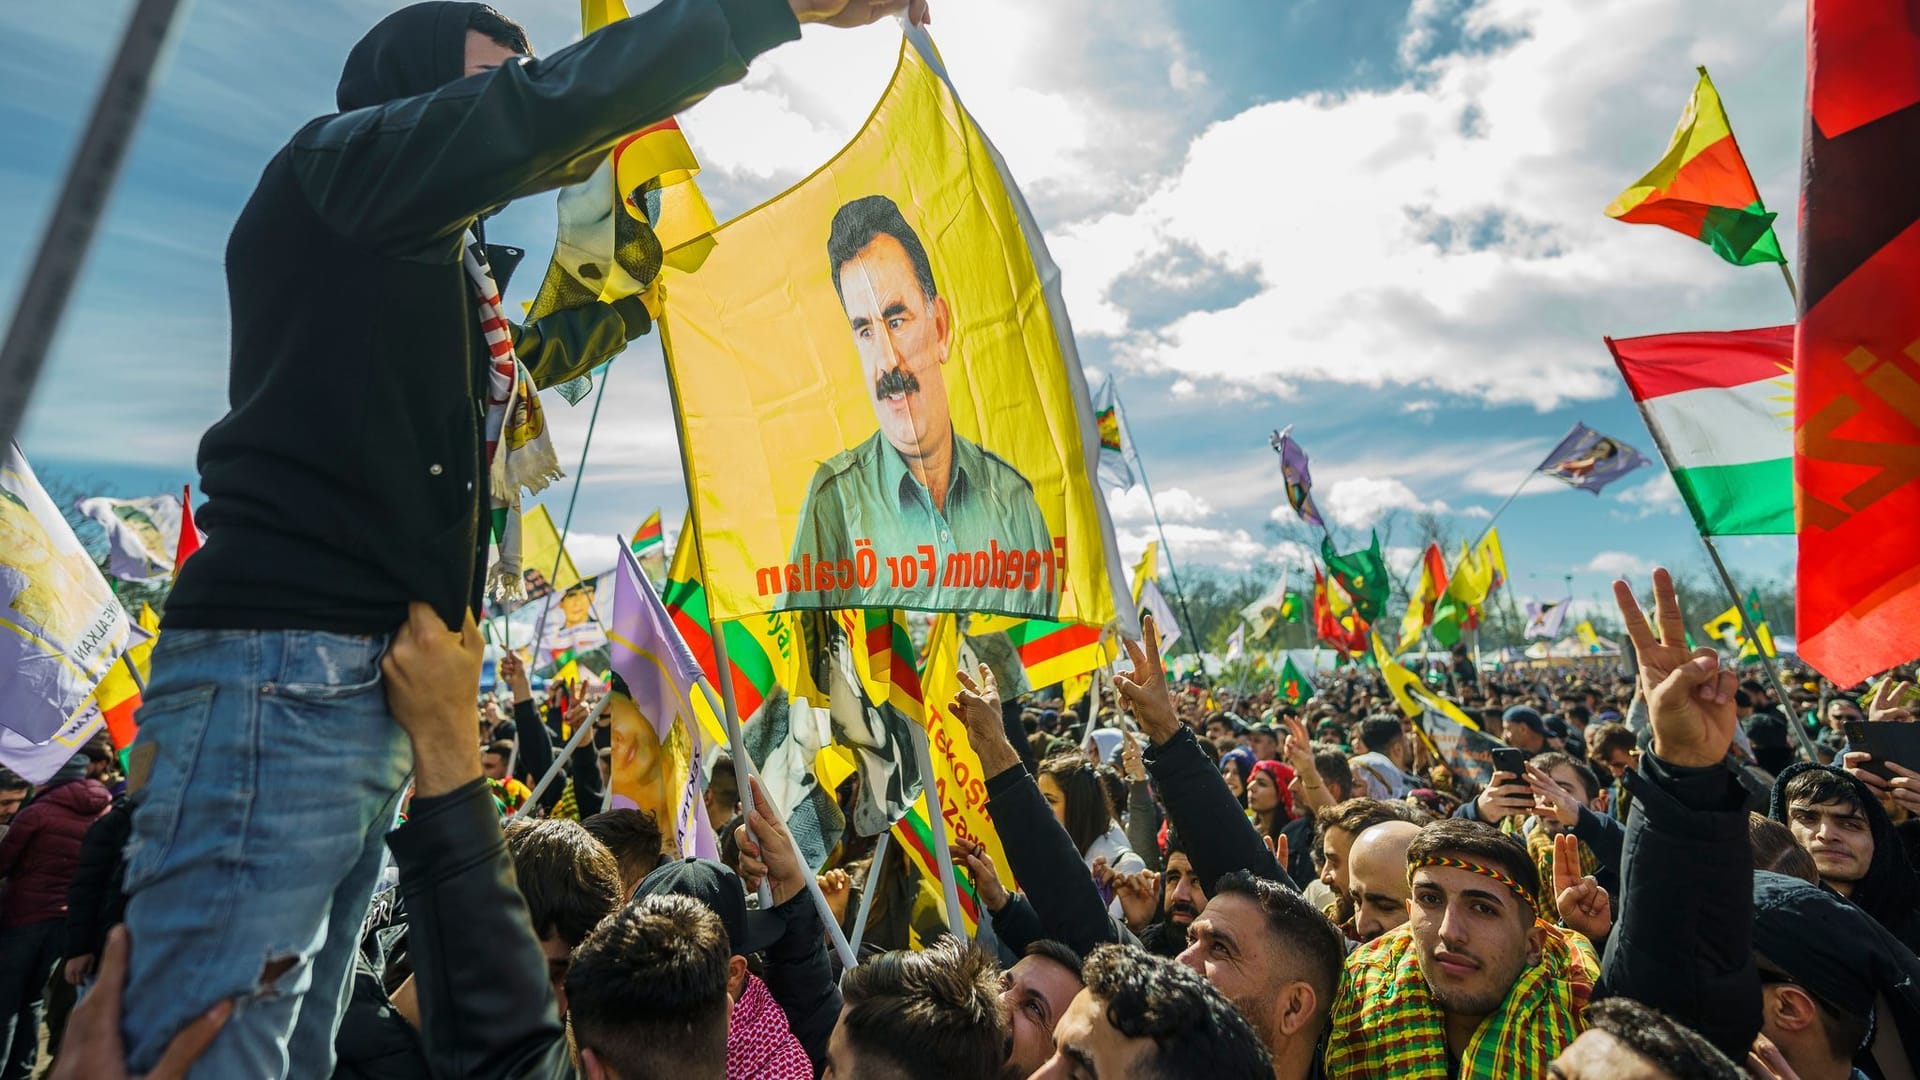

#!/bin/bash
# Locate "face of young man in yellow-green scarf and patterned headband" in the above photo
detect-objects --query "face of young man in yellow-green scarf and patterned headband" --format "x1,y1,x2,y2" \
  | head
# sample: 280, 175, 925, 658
1407, 867, 1542, 1017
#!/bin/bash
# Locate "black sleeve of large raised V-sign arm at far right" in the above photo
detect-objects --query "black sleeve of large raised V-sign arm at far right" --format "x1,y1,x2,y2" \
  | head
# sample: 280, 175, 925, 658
1594, 751, 1761, 1061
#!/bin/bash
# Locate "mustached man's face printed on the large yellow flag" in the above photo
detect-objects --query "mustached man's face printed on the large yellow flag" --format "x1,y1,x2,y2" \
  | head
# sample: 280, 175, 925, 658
839, 234, 952, 461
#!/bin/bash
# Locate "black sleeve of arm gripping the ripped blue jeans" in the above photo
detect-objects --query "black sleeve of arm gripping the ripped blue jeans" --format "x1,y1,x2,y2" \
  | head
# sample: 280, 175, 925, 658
386, 780, 572, 1078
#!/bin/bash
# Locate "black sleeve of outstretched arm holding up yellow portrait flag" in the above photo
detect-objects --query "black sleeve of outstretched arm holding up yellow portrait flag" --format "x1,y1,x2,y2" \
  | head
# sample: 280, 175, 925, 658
292, 0, 801, 252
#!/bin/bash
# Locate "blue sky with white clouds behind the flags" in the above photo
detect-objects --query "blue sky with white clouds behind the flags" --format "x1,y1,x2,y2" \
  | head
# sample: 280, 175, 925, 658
0, 0, 1805, 618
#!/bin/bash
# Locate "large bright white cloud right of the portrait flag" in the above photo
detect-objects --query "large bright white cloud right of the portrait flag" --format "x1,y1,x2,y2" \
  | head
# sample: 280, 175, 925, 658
1054, 0, 1797, 409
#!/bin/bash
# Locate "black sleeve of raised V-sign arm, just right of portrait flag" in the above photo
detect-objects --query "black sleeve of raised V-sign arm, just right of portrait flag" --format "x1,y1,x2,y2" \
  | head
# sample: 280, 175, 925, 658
1136, 726, 1300, 896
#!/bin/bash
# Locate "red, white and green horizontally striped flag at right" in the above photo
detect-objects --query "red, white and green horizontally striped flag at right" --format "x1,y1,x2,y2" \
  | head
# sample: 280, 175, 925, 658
1607, 327, 1793, 536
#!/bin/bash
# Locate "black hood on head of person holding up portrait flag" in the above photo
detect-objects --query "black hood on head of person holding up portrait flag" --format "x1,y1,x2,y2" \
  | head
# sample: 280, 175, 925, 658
334, 0, 486, 111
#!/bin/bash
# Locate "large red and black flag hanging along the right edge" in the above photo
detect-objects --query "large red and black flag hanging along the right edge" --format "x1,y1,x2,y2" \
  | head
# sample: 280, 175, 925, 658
1793, 0, 1920, 686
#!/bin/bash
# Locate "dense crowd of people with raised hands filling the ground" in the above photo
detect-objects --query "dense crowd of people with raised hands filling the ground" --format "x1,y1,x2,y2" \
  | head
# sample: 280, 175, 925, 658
0, 571, 1920, 1080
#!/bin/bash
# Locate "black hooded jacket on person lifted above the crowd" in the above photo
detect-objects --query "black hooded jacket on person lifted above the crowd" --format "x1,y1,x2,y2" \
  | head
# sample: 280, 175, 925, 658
165, 0, 799, 634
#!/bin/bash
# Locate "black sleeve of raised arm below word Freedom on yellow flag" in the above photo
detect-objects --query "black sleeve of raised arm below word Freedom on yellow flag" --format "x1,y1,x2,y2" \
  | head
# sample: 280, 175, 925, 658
987, 765, 1121, 957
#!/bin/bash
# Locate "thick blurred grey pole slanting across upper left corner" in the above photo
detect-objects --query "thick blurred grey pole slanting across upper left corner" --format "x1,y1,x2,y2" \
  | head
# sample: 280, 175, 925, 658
0, 0, 182, 446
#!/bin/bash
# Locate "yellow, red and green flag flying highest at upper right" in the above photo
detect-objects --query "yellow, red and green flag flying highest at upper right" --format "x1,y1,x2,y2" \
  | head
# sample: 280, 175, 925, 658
1607, 67, 1788, 267
